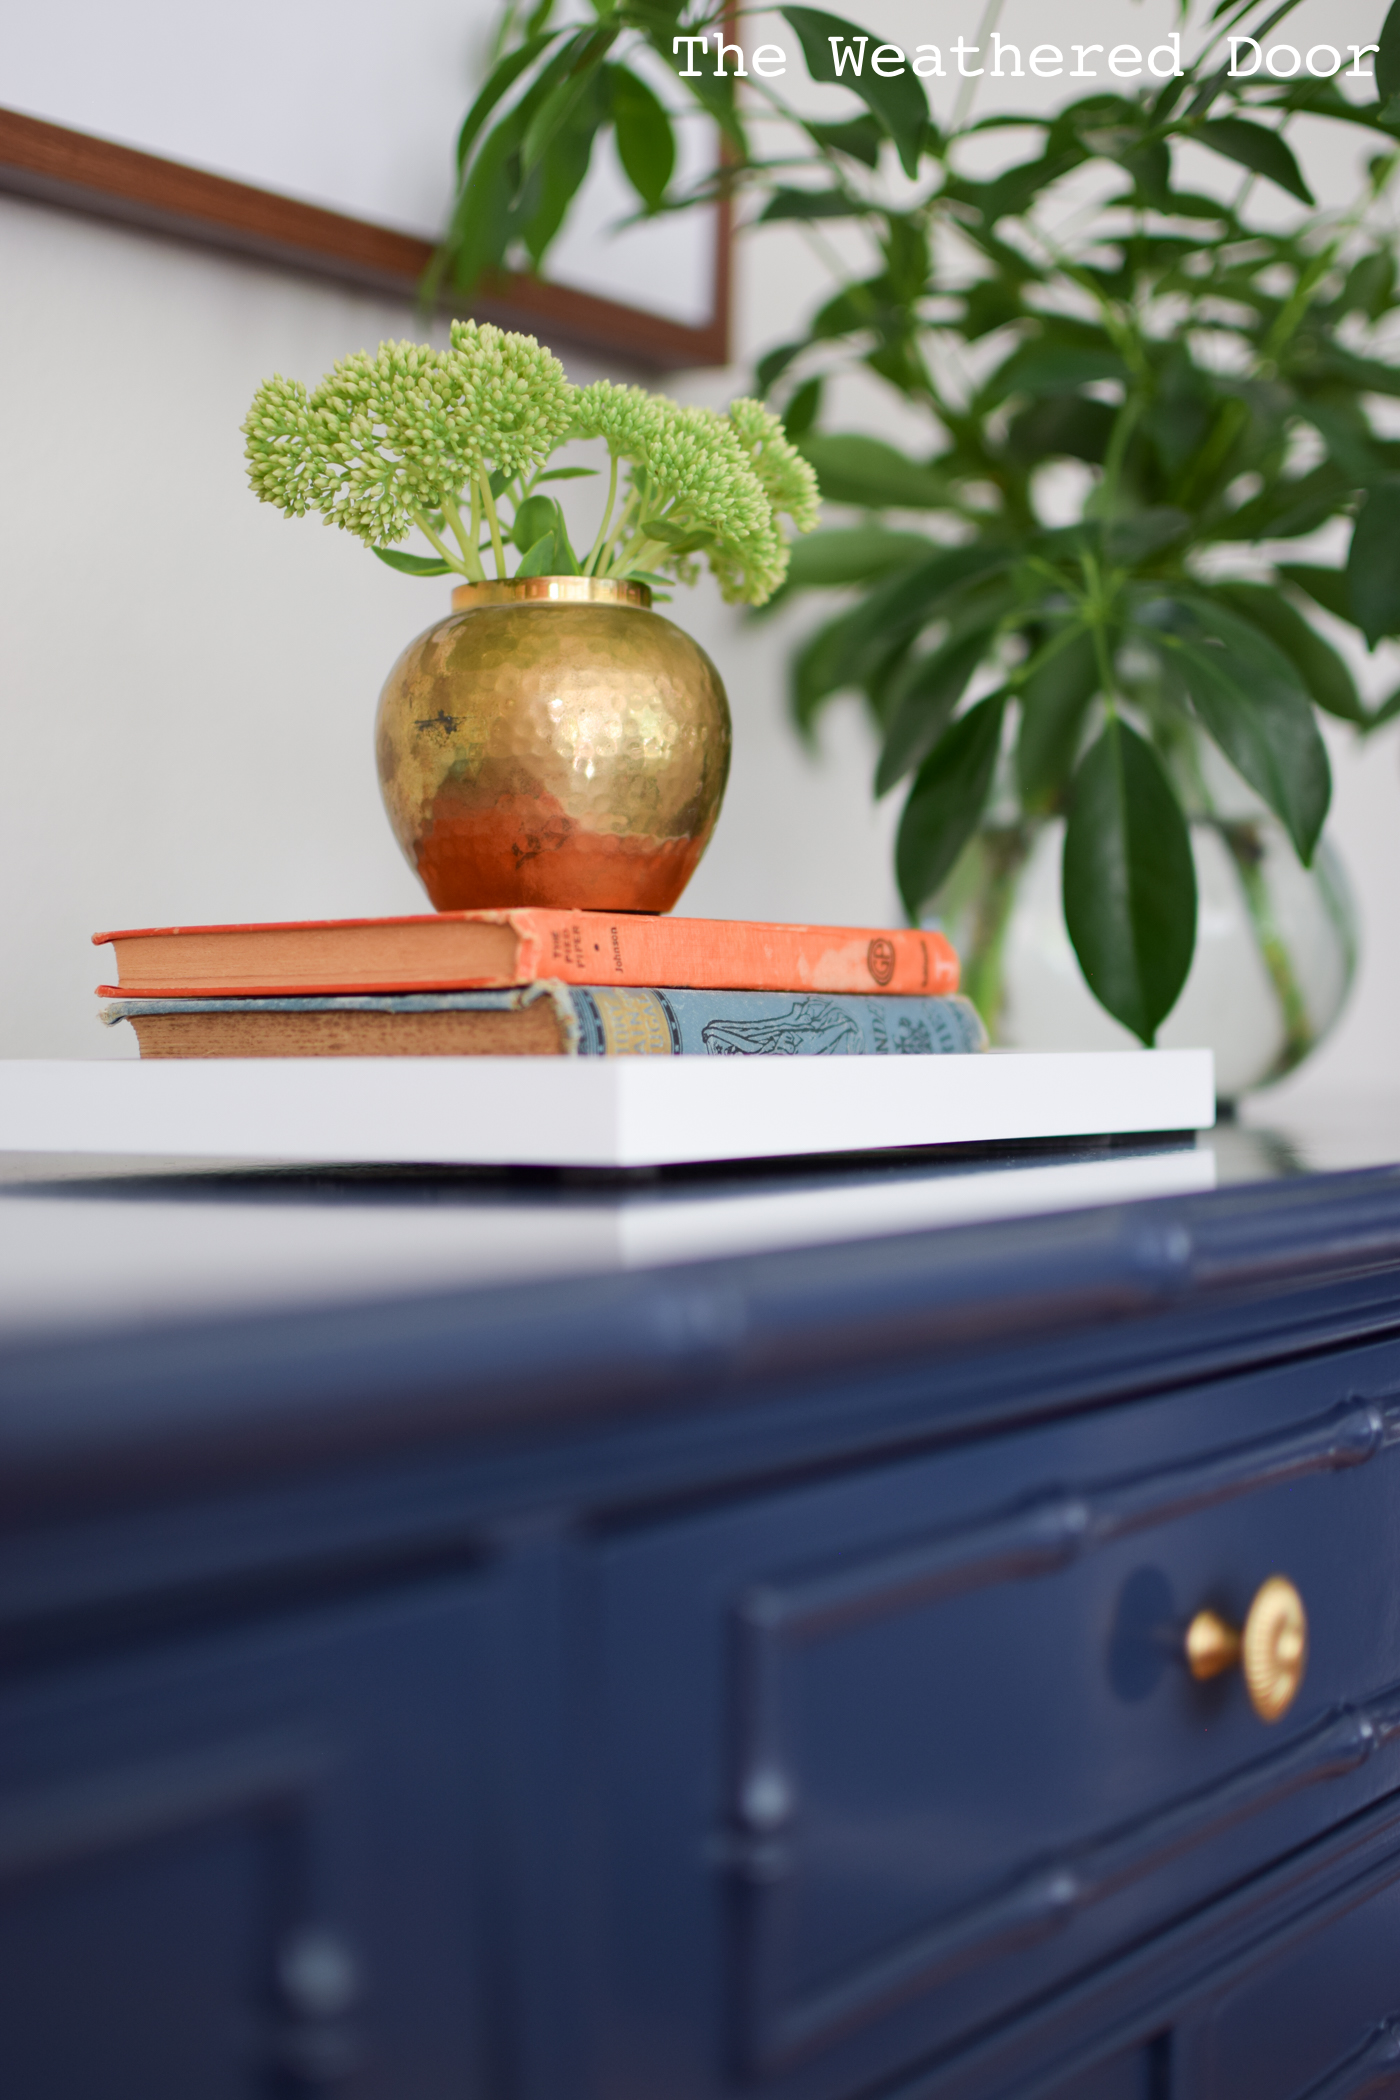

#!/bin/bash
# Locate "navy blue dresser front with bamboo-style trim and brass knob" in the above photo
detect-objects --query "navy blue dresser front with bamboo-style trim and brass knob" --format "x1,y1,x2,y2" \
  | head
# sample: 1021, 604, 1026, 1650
0, 1170, 1400, 2100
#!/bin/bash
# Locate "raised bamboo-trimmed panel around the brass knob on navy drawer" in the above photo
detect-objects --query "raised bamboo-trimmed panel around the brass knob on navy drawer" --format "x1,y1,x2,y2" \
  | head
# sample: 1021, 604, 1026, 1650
733, 1407, 1400, 2066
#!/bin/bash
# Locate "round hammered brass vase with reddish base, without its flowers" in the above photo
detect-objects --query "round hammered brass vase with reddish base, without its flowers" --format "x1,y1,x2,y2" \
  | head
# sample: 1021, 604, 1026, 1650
376, 575, 730, 911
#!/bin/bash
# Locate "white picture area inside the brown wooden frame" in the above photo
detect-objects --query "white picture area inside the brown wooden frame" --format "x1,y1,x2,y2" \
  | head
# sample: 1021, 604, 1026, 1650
0, 0, 714, 323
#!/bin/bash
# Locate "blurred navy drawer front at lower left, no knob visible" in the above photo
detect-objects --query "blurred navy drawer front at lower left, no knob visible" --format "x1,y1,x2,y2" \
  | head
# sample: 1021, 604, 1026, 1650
0, 1577, 485, 2100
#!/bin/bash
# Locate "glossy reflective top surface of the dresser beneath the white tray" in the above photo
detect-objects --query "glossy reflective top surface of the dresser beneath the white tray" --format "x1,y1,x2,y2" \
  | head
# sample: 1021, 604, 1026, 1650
0, 1092, 1400, 1344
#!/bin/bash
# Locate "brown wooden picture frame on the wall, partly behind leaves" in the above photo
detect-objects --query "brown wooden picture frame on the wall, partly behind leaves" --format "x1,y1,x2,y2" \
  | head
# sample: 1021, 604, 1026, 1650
0, 109, 733, 372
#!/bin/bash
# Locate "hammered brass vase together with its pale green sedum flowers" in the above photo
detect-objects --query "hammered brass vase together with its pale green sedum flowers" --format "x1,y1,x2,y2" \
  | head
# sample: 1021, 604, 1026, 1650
243, 321, 816, 911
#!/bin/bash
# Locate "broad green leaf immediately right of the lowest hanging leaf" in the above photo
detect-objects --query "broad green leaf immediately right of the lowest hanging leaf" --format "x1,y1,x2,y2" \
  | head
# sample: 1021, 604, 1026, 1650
1173, 601, 1333, 865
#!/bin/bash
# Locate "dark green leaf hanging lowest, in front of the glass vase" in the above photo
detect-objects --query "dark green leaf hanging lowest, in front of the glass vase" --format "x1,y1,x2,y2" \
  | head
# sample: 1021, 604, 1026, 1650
1062, 718, 1196, 1048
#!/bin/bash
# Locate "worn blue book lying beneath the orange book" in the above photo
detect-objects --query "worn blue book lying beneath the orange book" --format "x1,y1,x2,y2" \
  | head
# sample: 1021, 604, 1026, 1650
103, 981, 987, 1056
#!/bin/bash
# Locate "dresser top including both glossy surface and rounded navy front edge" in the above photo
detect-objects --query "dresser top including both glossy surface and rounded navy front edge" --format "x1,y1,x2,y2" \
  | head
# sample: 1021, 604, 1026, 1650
0, 1105, 1400, 1510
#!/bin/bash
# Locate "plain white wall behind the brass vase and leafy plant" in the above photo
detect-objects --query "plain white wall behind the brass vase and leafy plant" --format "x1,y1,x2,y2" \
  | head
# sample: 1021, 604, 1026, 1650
0, 0, 1400, 1092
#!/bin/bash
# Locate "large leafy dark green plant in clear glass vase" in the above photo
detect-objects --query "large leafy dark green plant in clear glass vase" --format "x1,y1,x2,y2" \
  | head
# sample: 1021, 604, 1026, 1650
437, 0, 1400, 1092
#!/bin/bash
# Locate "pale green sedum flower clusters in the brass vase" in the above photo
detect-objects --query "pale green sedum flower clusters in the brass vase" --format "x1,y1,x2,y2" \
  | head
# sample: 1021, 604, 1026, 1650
243, 321, 816, 605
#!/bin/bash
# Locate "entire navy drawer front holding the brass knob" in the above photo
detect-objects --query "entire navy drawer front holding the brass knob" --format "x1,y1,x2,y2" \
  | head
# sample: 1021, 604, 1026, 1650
602, 1357, 1400, 2092
